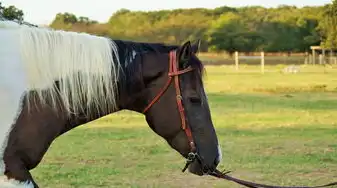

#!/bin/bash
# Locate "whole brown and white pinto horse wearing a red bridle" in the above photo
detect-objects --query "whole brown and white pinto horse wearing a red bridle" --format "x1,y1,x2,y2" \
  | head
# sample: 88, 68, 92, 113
0, 21, 221, 188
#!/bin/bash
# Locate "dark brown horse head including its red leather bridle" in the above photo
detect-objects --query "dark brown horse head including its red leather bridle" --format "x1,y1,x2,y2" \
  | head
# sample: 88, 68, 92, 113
120, 42, 221, 175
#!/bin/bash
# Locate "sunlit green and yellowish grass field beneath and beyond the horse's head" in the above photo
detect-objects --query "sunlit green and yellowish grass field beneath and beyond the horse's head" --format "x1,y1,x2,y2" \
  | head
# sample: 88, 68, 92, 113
32, 66, 337, 188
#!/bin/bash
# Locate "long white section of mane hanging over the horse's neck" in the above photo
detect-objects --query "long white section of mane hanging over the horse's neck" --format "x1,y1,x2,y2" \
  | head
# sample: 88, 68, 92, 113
0, 21, 120, 117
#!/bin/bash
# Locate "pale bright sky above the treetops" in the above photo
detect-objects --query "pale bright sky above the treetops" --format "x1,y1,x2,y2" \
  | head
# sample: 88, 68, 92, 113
0, 0, 332, 25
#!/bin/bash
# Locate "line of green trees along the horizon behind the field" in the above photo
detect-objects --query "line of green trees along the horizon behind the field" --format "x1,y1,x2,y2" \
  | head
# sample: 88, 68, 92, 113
0, 0, 337, 53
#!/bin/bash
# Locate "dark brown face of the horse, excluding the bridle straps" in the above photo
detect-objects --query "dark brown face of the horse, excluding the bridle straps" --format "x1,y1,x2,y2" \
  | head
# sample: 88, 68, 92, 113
121, 42, 221, 175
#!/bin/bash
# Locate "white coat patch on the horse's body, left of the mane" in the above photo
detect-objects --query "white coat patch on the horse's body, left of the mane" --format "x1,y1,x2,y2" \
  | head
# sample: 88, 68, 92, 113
0, 26, 27, 173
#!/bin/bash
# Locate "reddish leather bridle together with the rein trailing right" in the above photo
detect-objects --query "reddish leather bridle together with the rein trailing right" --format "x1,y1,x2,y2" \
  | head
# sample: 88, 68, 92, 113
143, 50, 337, 188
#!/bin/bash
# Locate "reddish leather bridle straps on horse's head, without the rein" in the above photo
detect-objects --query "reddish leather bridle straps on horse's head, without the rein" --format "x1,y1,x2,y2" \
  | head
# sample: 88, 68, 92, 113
143, 50, 198, 172
